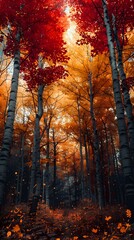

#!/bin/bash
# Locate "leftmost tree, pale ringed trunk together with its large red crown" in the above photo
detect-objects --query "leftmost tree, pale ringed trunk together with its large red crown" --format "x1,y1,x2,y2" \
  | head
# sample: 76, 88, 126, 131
0, 0, 67, 205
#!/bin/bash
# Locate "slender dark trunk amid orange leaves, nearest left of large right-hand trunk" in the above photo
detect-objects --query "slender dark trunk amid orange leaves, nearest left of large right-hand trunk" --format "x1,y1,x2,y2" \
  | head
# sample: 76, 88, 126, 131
88, 74, 104, 208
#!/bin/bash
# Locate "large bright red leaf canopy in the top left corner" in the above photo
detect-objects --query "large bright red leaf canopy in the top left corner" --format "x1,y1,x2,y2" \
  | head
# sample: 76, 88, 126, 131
0, 0, 68, 85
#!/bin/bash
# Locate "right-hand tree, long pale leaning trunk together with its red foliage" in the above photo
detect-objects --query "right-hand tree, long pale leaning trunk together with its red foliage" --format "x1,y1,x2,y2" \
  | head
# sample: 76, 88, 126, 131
68, 0, 134, 216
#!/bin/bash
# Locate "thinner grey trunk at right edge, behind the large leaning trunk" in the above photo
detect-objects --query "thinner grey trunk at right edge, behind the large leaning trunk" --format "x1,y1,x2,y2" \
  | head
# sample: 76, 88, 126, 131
113, 15, 134, 172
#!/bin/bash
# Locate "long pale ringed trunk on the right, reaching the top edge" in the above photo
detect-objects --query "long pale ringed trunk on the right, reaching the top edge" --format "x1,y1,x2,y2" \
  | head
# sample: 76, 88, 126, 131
102, 0, 134, 213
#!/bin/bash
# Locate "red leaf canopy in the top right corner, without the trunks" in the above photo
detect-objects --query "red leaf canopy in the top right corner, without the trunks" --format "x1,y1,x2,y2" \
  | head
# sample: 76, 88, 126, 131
68, 0, 134, 54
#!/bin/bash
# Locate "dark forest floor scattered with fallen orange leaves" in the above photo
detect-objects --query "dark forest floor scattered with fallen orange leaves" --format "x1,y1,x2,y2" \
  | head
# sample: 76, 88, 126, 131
0, 201, 134, 240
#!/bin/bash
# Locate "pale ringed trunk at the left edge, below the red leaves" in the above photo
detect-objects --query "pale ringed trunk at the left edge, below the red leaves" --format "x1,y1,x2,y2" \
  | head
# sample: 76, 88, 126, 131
0, 33, 20, 206
